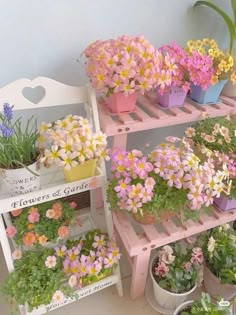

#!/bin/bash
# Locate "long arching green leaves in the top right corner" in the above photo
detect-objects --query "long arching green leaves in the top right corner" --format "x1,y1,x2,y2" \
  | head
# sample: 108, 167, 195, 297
194, 0, 236, 53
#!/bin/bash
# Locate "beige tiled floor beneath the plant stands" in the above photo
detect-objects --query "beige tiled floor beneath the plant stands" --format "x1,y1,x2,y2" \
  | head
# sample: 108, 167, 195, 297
0, 243, 159, 315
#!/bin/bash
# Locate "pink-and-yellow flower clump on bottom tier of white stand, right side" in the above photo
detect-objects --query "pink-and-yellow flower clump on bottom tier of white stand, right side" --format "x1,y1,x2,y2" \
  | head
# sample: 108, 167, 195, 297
56, 230, 121, 289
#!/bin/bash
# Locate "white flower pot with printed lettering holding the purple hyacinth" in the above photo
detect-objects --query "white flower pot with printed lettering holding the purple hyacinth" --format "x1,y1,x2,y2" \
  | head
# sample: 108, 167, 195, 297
1, 161, 40, 196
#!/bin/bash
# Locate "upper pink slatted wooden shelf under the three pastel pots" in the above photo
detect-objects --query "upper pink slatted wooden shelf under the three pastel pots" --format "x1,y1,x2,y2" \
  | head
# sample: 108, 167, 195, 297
98, 92, 236, 136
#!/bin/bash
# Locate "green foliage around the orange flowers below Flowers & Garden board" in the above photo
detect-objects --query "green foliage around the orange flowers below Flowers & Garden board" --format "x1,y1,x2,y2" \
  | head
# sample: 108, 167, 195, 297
13, 200, 75, 246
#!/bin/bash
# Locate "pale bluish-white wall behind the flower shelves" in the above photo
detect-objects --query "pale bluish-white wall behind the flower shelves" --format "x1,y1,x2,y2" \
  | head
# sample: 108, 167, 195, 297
0, 0, 230, 151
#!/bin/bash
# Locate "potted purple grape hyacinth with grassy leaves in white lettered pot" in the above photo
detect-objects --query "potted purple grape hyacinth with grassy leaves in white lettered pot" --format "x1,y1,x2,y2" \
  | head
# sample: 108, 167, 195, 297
0, 103, 40, 196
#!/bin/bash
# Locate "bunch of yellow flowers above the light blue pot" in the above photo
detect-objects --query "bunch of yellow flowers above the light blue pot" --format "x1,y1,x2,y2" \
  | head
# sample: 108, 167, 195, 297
186, 38, 236, 85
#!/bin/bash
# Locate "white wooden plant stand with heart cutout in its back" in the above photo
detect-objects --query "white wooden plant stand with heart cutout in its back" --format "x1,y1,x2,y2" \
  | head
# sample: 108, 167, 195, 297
0, 77, 123, 315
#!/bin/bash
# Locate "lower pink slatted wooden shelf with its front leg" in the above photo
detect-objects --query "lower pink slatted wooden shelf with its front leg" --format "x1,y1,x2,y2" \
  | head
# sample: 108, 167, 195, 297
113, 207, 236, 299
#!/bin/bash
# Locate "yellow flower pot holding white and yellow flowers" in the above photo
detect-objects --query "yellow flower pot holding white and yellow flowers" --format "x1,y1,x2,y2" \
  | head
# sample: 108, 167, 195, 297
63, 159, 97, 182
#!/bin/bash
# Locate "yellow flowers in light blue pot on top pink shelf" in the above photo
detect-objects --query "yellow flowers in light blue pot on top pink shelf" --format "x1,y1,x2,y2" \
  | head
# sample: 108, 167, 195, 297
187, 38, 236, 104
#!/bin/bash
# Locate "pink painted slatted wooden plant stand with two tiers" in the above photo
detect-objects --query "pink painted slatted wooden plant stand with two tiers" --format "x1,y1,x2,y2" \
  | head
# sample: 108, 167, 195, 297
98, 91, 236, 298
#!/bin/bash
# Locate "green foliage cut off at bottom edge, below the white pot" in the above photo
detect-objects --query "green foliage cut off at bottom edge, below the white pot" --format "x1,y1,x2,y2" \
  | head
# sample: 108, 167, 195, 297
180, 292, 230, 315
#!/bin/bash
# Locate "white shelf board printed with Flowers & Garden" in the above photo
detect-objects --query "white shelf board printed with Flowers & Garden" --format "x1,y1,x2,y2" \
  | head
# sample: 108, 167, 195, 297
0, 168, 106, 214
